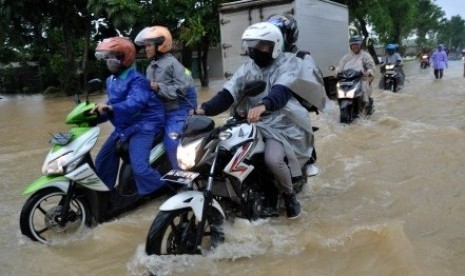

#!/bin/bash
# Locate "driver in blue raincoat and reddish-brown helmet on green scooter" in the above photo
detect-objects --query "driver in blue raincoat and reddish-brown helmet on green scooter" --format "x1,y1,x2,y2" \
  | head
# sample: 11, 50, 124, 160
92, 37, 165, 195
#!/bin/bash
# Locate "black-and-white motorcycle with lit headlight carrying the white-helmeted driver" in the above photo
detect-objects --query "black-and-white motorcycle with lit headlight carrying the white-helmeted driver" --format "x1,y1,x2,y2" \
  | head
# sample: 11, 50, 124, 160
145, 81, 306, 255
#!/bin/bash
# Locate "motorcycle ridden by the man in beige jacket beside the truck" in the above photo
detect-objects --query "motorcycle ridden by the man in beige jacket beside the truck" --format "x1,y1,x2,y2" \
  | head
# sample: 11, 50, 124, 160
330, 66, 374, 124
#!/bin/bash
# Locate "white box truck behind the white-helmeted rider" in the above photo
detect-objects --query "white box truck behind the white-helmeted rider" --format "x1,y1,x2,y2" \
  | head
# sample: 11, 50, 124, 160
219, 0, 349, 95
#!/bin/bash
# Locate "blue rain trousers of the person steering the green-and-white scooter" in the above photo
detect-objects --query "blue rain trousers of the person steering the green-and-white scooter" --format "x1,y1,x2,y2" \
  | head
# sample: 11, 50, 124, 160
95, 133, 165, 195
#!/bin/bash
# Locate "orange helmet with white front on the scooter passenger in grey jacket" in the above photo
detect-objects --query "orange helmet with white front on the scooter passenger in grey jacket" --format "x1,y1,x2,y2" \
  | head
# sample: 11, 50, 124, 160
134, 26, 173, 53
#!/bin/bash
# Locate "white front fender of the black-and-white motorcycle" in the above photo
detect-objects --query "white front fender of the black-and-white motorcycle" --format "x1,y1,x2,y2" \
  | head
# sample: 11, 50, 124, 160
160, 191, 226, 221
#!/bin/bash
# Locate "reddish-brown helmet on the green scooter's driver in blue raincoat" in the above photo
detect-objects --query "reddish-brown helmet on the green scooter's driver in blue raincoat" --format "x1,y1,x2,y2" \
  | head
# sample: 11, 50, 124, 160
95, 36, 136, 67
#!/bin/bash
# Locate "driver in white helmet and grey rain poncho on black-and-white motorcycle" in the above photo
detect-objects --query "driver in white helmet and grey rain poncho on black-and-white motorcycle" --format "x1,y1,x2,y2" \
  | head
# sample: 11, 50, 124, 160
197, 22, 312, 219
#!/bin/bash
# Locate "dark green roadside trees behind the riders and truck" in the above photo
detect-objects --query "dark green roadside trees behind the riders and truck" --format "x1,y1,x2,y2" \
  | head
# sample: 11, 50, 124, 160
0, 0, 465, 95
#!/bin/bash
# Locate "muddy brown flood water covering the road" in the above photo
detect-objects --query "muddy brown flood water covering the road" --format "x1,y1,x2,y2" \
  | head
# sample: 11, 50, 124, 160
0, 61, 465, 276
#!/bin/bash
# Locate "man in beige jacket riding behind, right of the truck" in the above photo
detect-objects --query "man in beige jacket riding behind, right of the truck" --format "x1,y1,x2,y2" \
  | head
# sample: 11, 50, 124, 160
335, 36, 375, 110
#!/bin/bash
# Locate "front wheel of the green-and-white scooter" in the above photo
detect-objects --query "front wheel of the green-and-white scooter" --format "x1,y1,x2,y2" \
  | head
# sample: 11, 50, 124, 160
19, 188, 92, 244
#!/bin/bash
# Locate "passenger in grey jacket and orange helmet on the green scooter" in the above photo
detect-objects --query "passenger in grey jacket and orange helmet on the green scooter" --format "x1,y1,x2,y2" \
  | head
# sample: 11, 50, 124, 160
134, 26, 197, 169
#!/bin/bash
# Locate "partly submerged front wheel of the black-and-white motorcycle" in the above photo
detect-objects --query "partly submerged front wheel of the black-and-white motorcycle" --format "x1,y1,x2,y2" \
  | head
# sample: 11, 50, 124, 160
145, 208, 224, 255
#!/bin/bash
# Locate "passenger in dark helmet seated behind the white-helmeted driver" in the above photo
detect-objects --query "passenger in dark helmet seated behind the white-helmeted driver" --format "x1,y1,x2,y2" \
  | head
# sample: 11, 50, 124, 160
267, 14, 324, 176
